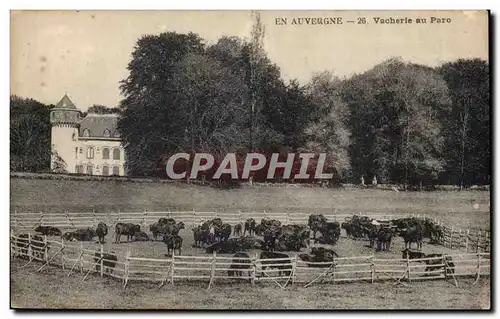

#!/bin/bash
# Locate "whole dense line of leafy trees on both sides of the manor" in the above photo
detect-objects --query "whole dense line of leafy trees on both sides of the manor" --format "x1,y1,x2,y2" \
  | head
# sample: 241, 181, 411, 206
11, 17, 491, 187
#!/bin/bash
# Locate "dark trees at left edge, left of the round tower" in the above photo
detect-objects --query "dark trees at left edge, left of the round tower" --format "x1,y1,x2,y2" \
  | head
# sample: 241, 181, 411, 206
10, 95, 53, 172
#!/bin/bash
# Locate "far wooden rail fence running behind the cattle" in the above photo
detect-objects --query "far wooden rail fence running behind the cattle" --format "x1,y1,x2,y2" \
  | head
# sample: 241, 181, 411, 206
11, 210, 491, 252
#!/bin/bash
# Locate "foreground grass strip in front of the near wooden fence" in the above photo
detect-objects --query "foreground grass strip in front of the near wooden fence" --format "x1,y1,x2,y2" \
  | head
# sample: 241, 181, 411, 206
11, 261, 490, 309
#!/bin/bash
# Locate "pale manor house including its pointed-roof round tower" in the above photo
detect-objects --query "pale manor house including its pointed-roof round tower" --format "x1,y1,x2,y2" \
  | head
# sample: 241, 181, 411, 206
50, 95, 125, 176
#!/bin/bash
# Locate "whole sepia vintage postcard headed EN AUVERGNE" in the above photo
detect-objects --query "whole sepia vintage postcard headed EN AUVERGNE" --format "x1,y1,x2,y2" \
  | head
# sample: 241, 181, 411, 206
10, 11, 492, 311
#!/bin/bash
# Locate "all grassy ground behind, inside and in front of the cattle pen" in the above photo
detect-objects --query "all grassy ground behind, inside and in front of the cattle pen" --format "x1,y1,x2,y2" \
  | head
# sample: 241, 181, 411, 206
11, 178, 490, 309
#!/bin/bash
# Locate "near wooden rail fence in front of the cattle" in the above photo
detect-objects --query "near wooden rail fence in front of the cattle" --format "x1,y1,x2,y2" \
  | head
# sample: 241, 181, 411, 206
11, 235, 490, 289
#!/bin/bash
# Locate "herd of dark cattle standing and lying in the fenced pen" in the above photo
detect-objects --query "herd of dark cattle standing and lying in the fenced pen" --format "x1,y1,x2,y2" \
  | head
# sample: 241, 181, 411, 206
11, 214, 454, 276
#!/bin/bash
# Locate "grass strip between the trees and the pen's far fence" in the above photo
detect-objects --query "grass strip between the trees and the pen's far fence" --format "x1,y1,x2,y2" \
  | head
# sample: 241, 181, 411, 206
10, 178, 490, 228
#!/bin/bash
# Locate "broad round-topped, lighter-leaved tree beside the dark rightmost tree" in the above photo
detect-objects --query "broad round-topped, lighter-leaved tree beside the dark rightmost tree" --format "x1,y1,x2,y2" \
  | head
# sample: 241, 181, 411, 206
345, 59, 450, 185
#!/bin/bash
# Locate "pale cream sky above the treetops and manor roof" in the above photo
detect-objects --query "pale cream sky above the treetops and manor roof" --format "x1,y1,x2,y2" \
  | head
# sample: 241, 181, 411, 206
11, 11, 488, 110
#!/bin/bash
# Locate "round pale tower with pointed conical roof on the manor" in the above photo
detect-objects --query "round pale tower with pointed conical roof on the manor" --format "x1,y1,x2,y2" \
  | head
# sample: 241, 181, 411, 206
50, 94, 81, 173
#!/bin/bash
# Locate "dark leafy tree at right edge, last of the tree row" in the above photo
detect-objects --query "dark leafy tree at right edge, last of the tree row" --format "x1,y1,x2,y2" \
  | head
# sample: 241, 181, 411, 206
438, 59, 491, 187
